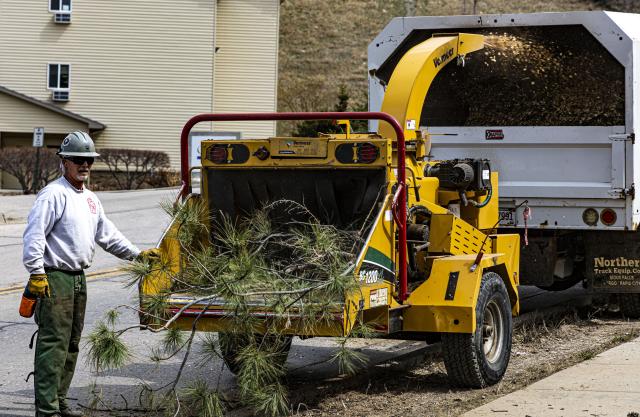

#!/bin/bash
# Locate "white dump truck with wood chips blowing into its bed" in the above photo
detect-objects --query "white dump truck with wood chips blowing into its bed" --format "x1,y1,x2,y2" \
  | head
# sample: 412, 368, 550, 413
368, 12, 640, 317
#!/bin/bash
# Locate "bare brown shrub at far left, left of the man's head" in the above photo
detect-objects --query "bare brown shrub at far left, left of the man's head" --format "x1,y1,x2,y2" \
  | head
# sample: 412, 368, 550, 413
0, 147, 60, 194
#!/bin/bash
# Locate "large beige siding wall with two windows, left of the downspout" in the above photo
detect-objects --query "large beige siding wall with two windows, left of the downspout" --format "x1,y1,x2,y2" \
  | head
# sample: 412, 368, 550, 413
0, 0, 215, 167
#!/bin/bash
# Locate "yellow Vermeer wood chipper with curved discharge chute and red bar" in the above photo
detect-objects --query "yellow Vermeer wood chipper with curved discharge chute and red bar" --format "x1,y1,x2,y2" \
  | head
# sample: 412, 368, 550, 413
140, 34, 520, 387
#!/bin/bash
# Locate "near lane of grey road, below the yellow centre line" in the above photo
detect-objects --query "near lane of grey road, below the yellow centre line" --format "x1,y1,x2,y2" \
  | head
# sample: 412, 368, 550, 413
0, 277, 436, 417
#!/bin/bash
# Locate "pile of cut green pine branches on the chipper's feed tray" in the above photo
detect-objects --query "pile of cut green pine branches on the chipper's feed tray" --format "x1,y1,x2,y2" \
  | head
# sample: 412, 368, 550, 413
88, 200, 376, 417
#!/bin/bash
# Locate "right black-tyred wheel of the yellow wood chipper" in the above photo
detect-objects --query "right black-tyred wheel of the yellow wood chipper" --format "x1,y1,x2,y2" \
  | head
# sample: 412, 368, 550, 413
442, 272, 512, 388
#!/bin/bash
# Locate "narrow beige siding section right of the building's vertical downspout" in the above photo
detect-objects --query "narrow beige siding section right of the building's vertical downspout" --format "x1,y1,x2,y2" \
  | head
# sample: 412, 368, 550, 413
214, 0, 279, 137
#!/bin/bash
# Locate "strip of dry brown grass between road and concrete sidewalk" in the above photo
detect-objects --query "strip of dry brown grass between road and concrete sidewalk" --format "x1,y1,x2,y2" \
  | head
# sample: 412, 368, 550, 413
292, 310, 640, 416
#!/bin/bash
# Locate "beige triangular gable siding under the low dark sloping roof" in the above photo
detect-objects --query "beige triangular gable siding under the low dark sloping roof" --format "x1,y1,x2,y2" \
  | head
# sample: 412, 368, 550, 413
0, 92, 87, 132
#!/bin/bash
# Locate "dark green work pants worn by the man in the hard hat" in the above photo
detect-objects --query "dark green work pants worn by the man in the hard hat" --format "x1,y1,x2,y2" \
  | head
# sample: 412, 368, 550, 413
34, 270, 87, 415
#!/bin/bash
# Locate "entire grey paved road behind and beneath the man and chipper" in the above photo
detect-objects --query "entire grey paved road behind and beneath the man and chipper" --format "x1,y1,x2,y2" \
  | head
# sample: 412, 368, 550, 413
0, 190, 592, 417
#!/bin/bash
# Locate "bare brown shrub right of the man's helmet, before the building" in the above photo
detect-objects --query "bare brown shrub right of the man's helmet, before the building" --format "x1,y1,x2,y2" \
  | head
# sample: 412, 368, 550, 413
99, 149, 169, 190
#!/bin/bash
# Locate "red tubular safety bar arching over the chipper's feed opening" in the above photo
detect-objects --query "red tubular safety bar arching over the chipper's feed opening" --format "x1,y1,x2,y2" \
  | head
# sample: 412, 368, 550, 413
178, 112, 407, 302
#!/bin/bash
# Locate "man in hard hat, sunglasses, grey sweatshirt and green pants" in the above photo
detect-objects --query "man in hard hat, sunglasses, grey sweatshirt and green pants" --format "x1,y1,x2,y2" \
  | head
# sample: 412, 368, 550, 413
23, 132, 157, 417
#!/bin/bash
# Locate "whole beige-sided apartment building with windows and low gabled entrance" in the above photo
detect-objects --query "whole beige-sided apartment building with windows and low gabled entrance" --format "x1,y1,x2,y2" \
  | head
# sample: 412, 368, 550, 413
0, 0, 280, 188
